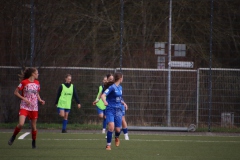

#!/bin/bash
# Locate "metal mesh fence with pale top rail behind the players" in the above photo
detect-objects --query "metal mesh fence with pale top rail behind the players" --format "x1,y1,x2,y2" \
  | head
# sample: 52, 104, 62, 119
0, 67, 240, 129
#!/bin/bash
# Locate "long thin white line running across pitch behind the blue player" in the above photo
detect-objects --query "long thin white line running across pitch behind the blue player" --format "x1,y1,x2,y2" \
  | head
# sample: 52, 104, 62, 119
37, 139, 240, 143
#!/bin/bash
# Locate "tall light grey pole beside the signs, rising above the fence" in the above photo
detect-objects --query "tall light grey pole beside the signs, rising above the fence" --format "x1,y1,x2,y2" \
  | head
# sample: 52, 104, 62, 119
167, 0, 172, 127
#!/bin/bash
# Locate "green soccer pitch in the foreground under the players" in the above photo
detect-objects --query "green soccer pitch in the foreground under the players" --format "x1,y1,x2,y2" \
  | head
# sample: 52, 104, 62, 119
0, 131, 240, 160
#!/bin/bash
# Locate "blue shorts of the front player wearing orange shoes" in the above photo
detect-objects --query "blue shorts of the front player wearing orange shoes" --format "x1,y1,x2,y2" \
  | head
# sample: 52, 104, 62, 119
106, 107, 122, 128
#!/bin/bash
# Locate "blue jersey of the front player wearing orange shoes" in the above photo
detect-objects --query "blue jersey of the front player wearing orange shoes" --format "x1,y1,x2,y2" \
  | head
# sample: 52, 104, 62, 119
104, 84, 122, 108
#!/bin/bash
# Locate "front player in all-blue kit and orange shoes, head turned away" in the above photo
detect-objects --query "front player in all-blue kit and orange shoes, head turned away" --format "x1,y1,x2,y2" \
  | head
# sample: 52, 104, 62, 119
101, 72, 123, 150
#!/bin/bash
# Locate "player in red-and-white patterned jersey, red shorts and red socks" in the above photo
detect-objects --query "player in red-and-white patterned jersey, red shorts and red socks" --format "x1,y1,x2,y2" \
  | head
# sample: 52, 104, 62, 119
8, 68, 45, 149
